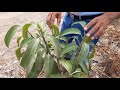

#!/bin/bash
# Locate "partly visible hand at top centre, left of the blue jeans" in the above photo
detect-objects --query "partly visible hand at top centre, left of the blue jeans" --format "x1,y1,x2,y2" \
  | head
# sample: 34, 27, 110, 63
46, 12, 62, 27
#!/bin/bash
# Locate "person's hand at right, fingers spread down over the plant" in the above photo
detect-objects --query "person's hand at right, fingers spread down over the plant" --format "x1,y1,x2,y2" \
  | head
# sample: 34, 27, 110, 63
84, 13, 120, 40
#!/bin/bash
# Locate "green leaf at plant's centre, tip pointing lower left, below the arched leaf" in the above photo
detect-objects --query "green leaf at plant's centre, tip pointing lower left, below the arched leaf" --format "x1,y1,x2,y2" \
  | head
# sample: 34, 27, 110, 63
60, 44, 77, 57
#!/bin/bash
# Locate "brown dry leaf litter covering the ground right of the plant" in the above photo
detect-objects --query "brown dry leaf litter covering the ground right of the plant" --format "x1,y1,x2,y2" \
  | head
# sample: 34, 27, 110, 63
90, 20, 120, 78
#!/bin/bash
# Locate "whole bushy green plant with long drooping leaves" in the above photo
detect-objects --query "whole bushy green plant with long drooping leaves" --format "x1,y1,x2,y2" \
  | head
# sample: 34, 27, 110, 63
4, 22, 95, 78
